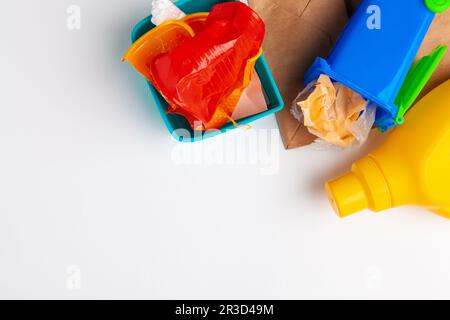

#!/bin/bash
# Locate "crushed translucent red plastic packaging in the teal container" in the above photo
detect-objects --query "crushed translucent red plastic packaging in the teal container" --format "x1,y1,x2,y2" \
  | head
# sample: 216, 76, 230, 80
123, 2, 265, 130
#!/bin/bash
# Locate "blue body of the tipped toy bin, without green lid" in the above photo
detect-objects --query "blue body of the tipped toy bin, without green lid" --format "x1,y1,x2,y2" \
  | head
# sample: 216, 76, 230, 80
305, 0, 442, 131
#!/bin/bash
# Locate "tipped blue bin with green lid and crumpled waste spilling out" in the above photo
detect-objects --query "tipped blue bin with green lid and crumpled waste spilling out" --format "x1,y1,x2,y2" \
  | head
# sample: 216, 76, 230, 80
293, 0, 448, 147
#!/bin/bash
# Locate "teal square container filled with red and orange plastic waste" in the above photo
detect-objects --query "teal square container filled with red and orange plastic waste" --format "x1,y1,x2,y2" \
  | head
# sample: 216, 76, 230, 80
124, 0, 283, 142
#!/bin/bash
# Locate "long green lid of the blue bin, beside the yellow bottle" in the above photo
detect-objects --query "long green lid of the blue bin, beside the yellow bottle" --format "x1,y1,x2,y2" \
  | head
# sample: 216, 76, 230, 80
395, 46, 448, 125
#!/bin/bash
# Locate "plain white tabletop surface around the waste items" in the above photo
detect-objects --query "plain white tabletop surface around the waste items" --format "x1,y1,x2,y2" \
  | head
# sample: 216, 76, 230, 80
0, 0, 450, 299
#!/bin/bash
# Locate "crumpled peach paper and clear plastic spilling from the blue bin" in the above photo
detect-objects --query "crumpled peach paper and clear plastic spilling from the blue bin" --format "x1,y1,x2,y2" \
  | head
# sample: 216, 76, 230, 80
291, 75, 376, 148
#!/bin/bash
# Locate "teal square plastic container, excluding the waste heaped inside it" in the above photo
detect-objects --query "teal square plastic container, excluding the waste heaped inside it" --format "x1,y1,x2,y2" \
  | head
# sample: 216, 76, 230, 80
131, 0, 284, 142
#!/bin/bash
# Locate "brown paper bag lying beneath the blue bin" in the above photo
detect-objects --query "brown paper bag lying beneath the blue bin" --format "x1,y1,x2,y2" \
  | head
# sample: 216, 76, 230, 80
249, 0, 450, 149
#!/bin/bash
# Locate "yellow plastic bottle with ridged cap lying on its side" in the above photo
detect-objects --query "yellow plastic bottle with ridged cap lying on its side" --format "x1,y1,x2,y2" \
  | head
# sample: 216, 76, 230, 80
325, 80, 450, 218
